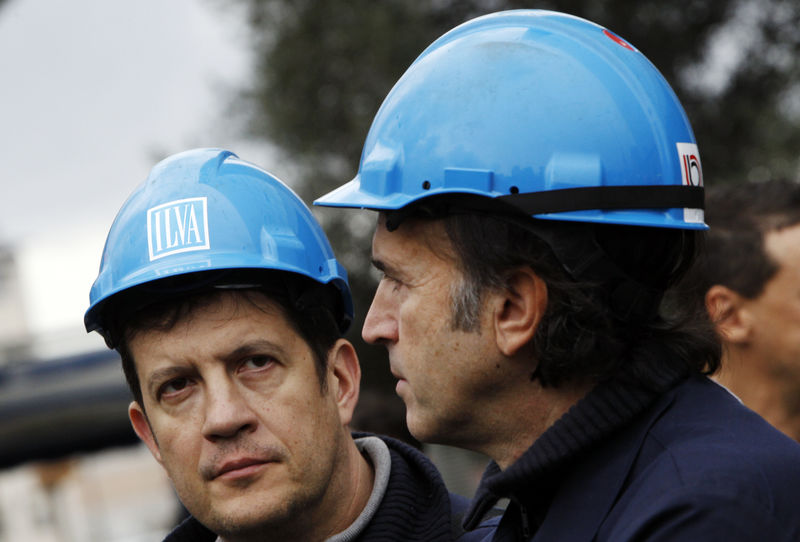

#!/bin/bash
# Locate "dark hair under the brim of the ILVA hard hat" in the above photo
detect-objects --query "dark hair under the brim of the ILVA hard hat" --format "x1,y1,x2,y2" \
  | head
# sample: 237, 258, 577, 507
103, 271, 342, 407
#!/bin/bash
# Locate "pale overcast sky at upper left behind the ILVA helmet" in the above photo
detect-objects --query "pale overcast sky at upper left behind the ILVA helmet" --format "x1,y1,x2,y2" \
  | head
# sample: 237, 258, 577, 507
0, 0, 274, 356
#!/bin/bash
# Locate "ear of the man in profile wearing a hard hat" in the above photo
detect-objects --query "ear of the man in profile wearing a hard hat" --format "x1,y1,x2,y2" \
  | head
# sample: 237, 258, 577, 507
491, 266, 547, 357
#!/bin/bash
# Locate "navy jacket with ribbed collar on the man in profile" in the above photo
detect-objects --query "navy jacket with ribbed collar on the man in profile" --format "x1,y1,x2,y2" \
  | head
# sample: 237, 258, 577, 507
466, 377, 800, 542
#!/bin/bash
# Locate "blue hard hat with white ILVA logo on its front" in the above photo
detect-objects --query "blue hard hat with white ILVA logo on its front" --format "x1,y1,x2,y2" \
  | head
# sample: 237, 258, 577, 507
84, 149, 353, 333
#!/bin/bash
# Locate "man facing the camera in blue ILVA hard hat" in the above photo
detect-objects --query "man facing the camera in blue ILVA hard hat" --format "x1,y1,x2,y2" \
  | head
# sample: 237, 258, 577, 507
85, 149, 490, 542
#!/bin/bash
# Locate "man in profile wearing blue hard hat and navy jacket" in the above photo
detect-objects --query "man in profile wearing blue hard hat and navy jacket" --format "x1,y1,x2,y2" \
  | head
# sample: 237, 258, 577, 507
316, 10, 800, 542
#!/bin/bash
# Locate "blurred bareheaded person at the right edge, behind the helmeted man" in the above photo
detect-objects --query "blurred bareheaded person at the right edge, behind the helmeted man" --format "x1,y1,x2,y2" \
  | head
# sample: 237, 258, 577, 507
678, 179, 800, 441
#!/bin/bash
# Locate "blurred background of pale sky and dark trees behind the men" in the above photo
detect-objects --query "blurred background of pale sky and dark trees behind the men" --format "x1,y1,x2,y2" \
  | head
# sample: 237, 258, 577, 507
0, 0, 800, 542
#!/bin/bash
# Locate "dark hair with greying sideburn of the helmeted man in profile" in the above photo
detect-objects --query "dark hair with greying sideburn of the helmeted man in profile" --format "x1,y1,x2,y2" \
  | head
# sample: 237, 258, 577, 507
418, 212, 721, 387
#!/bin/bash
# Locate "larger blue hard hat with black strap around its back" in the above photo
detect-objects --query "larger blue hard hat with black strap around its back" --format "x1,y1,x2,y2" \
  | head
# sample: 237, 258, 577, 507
315, 10, 706, 230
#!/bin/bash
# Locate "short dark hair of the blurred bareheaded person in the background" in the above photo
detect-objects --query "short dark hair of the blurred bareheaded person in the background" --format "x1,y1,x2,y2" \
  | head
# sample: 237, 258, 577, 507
678, 179, 800, 311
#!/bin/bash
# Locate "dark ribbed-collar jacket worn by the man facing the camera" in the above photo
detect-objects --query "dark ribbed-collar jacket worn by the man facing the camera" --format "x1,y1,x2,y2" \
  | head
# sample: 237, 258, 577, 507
164, 433, 494, 542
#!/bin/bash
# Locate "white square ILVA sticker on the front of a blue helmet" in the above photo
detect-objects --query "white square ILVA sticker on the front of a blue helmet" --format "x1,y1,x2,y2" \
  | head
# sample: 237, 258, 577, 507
147, 197, 210, 261
